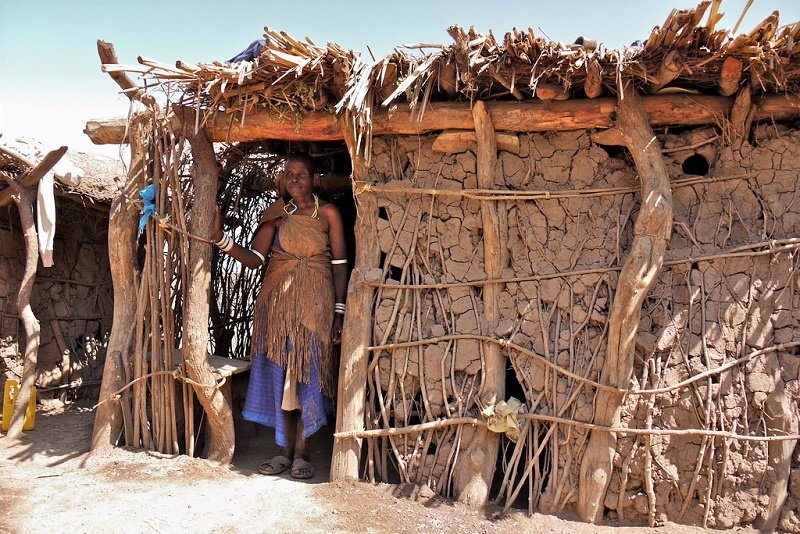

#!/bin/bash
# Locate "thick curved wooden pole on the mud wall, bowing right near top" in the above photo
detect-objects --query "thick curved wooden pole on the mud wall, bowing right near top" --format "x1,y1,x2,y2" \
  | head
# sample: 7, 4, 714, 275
578, 85, 673, 522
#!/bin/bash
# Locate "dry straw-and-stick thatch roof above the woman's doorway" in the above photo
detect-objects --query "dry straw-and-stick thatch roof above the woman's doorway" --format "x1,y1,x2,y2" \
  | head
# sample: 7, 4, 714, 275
108, 0, 800, 117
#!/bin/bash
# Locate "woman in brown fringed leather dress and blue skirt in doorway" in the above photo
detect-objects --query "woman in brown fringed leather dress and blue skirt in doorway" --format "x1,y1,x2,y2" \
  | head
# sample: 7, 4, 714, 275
214, 154, 347, 479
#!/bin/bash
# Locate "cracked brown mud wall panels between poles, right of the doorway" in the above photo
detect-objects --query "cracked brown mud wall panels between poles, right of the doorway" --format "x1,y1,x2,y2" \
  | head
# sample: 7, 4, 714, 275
368, 126, 800, 530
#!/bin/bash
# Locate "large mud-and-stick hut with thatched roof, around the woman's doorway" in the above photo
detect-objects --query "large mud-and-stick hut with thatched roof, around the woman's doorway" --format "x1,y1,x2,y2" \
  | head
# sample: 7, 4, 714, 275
87, 2, 800, 531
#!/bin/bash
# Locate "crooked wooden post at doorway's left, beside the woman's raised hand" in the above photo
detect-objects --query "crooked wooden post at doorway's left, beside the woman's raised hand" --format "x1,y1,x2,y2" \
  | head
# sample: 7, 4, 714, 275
182, 126, 235, 463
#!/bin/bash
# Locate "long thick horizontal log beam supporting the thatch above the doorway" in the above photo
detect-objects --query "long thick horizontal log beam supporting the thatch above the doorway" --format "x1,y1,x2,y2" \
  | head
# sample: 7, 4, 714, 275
84, 95, 800, 144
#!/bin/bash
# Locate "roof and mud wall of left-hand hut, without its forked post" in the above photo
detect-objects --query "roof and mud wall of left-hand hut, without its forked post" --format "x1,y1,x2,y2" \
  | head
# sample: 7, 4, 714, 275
0, 146, 119, 414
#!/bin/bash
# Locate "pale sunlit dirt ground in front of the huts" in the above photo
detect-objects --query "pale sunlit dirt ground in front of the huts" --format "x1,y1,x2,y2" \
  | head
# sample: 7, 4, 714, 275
0, 405, 748, 534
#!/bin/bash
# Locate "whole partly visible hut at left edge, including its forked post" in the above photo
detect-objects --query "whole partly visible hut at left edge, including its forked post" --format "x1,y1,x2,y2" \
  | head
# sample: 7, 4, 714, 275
0, 141, 119, 435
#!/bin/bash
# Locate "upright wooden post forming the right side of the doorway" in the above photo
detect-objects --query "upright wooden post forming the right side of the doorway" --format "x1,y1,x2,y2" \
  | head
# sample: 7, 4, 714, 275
330, 115, 380, 481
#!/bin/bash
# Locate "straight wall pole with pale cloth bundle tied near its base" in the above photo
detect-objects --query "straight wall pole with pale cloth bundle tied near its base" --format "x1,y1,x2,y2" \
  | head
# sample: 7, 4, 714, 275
453, 100, 506, 506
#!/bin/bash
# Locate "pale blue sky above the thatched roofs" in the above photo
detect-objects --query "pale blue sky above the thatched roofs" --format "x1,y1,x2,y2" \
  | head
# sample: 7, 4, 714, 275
0, 0, 800, 157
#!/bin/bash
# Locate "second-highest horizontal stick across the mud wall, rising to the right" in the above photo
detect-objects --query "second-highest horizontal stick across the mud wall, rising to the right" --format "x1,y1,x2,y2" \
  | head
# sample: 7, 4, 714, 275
361, 238, 800, 290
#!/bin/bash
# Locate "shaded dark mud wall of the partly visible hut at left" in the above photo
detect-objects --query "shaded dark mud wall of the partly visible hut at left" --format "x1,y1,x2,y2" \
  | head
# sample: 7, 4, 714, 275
0, 199, 113, 398
